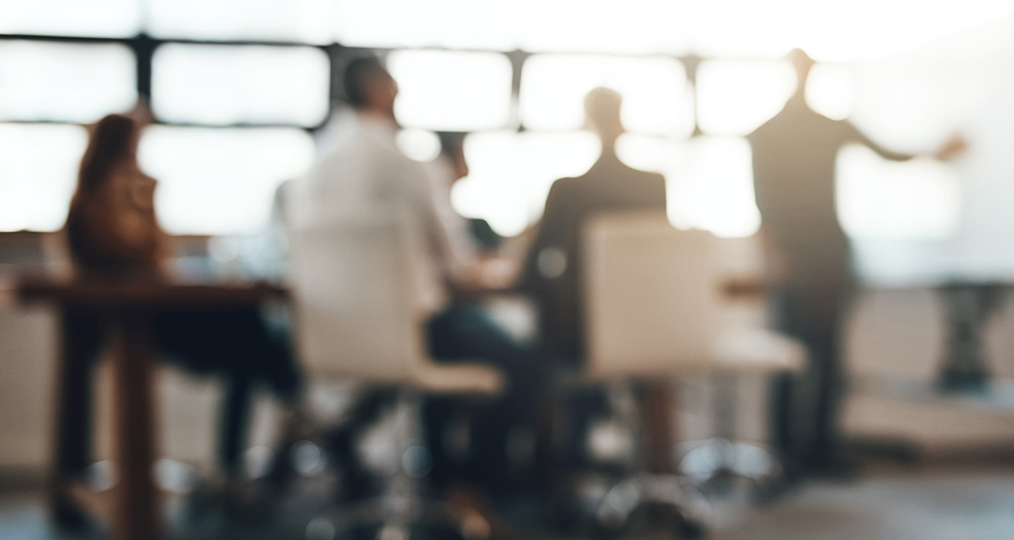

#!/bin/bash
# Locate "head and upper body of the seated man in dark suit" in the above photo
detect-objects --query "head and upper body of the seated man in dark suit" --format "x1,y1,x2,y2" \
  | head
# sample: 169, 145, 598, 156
520, 88, 665, 364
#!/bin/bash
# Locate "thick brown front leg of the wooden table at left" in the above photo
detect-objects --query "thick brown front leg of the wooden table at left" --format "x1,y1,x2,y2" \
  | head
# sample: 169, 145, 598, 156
113, 310, 160, 540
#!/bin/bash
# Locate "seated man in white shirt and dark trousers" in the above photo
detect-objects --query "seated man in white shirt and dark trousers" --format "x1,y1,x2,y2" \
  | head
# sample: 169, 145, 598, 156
289, 57, 541, 487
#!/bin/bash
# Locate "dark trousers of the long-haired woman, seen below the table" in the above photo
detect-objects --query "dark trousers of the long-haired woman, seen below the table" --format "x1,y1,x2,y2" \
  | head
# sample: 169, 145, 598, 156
57, 308, 301, 478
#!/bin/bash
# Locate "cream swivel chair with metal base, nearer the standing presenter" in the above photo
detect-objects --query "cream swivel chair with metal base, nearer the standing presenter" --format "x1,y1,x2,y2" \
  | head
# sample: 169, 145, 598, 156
584, 212, 802, 535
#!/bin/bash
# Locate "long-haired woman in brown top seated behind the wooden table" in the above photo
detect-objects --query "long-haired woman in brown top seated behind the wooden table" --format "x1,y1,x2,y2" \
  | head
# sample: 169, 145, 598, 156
57, 114, 301, 518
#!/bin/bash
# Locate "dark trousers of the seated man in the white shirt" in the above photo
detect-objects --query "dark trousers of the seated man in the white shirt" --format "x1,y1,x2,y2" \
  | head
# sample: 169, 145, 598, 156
426, 302, 546, 486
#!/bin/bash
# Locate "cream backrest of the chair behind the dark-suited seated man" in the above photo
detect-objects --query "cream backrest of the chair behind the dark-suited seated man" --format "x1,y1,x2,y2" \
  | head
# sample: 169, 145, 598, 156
584, 212, 720, 378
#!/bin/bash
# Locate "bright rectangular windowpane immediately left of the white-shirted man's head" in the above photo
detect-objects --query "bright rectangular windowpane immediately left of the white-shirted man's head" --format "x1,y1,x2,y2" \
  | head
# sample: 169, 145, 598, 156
152, 44, 330, 126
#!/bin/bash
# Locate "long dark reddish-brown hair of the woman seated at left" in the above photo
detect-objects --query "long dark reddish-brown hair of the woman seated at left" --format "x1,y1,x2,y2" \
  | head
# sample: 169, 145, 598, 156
77, 114, 137, 194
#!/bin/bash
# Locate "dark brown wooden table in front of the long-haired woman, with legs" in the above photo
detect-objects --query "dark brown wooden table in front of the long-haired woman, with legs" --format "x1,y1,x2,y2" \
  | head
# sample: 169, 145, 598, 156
17, 278, 285, 540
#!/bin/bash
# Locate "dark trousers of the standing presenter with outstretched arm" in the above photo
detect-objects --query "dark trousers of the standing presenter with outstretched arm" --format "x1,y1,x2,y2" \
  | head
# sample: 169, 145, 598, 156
772, 274, 853, 472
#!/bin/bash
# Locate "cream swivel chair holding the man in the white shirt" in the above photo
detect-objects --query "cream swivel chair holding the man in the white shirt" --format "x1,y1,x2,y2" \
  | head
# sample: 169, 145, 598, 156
290, 211, 504, 540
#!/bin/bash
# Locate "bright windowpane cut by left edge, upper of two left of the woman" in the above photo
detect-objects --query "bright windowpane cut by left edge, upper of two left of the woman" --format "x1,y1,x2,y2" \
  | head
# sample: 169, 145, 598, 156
0, 42, 137, 123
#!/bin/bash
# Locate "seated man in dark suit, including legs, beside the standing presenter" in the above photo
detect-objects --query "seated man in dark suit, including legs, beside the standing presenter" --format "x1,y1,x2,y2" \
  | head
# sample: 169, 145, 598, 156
519, 87, 669, 472
